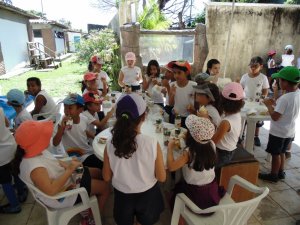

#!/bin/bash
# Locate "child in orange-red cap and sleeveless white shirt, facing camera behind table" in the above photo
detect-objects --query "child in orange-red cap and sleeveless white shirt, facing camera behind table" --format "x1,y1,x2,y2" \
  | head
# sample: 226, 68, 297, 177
169, 61, 197, 127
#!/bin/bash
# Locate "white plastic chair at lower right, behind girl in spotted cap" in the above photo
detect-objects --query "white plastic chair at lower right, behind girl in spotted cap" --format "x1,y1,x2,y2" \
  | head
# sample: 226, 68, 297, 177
171, 175, 269, 225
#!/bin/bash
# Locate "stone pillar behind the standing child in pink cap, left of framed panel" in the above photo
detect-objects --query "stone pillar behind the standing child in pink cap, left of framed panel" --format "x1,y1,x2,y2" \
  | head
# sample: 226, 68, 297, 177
120, 23, 143, 68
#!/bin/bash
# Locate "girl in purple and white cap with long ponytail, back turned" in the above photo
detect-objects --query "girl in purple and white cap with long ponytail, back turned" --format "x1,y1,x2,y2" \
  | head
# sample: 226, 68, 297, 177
103, 93, 166, 225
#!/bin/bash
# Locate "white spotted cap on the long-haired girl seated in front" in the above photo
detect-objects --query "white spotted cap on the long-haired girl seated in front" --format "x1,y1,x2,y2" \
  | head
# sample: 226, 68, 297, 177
185, 115, 215, 144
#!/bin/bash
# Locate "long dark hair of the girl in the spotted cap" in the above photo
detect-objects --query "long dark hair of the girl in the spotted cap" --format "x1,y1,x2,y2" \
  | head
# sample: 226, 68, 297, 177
186, 131, 217, 172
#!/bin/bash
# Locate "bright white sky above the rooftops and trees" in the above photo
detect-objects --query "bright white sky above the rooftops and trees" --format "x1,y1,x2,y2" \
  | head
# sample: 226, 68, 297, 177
12, 0, 205, 31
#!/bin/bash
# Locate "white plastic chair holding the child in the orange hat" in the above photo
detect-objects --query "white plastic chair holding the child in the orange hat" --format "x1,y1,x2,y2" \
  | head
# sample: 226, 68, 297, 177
23, 180, 102, 225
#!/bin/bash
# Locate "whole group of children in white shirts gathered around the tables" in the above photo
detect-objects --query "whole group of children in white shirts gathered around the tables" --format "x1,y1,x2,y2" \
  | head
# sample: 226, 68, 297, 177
0, 48, 300, 225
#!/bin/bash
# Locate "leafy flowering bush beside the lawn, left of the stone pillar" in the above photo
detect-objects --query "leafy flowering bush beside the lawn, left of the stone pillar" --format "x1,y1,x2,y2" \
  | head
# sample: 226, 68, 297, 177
76, 29, 121, 90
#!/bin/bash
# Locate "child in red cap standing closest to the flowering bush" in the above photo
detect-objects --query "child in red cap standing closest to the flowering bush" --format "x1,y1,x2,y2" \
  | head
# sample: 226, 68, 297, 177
90, 55, 110, 91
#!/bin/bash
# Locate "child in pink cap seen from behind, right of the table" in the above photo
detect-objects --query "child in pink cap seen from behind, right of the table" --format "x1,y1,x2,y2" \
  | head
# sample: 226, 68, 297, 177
212, 82, 244, 168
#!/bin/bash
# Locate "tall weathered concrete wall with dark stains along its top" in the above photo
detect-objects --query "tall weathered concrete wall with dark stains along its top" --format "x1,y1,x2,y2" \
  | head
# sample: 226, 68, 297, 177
205, 3, 300, 78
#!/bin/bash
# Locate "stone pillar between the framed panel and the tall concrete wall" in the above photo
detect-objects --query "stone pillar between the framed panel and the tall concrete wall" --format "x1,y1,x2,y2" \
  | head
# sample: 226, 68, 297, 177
193, 23, 208, 74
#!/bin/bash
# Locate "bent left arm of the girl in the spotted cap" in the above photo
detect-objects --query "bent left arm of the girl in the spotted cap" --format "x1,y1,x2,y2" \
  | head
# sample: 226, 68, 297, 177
167, 140, 189, 171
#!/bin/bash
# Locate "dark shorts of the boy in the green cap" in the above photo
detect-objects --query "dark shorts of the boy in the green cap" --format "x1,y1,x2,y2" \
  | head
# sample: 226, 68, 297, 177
266, 134, 293, 155
